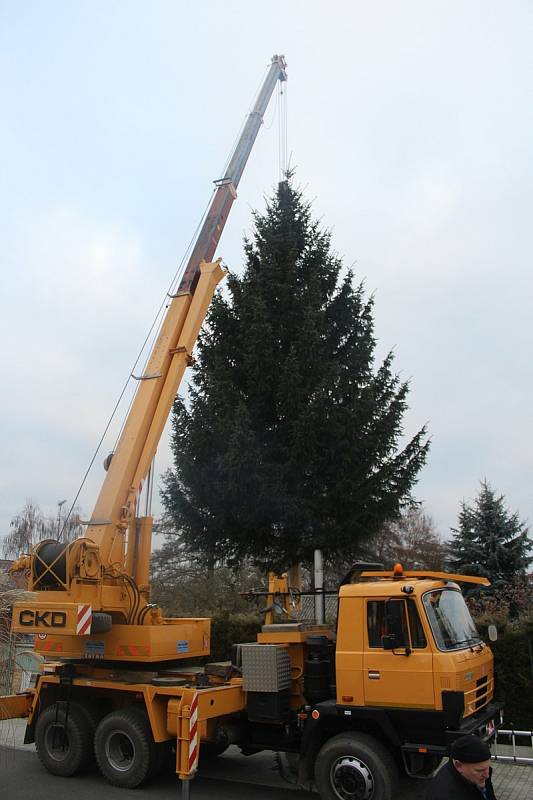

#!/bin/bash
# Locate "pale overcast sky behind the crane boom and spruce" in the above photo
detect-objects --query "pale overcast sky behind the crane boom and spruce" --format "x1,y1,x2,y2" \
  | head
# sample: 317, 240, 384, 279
0, 0, 533, 552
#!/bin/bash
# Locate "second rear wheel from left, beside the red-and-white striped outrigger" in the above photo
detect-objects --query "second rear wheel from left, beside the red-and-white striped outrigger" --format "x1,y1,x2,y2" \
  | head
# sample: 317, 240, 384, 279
94, 706, 158, 789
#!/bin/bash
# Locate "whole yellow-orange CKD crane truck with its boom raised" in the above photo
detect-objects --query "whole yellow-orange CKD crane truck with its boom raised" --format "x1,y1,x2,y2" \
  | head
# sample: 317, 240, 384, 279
0, 56, 500, 800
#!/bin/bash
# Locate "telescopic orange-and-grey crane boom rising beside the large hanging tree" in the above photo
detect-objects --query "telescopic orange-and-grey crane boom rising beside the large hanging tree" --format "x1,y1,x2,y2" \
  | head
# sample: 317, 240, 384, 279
88, 55, 287, 564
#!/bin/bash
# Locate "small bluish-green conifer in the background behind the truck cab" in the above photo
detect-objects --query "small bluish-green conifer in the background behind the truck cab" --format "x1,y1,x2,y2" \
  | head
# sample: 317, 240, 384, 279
449, 480, 533, 586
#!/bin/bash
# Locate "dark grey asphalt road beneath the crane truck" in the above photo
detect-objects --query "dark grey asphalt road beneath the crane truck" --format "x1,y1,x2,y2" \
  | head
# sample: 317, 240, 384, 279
0, 747, 425, 800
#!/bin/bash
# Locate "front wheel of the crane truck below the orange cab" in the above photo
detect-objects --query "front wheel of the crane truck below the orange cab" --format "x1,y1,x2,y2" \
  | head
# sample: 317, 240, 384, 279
315, 733, 396, 800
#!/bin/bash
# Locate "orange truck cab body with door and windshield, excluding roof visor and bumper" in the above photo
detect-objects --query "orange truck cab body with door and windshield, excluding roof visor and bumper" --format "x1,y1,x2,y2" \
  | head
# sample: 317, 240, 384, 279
336, 578, 494, 716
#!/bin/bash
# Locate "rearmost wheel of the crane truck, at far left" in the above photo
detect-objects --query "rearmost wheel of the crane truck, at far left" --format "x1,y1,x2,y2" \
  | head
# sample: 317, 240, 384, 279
35, 702, 93, 778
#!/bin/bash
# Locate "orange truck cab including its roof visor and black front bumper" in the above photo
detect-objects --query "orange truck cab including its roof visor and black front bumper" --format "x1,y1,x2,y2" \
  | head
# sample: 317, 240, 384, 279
322, 565, 501, 777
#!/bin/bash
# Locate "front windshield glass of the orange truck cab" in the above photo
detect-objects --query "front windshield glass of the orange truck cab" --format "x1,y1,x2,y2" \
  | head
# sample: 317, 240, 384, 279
423, 589, 481, 650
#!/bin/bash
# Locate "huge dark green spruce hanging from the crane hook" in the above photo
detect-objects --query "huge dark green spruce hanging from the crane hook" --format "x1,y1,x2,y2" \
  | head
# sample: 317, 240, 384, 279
162, 181, 429, 568
